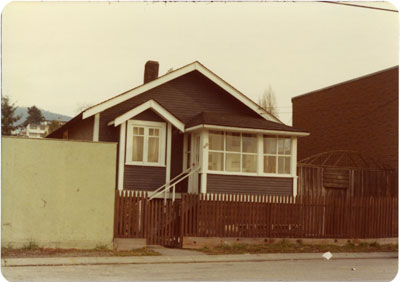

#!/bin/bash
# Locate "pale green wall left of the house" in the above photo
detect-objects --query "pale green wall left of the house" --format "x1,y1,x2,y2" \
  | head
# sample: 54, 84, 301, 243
1, 137, 116, 249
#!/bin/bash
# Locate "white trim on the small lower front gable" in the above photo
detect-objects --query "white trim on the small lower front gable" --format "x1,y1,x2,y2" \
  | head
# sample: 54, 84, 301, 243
108, 100, 185, 132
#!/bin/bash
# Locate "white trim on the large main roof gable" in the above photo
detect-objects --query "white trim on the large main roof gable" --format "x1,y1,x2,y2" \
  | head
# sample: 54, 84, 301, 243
82, 62, 282, 123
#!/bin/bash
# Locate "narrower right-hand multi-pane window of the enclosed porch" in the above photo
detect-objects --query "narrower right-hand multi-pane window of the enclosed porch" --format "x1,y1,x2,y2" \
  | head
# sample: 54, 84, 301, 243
264, 135, 291, 174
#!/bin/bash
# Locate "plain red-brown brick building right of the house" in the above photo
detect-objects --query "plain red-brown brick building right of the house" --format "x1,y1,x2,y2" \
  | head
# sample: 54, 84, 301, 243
292, 66, 399, 169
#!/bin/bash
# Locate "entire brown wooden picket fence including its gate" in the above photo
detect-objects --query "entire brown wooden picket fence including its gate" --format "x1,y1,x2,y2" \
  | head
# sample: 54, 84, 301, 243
114, 191, 398, 247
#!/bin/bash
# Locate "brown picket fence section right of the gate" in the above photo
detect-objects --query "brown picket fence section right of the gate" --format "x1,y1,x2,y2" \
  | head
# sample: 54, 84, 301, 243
182, 194, 398, 238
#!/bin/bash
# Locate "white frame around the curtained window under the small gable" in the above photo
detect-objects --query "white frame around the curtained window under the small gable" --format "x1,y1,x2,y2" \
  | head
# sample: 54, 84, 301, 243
125, 120, 166, 167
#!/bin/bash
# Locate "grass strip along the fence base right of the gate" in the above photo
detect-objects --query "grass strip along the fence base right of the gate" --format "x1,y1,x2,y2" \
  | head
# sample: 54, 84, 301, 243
200, 240, 398, 255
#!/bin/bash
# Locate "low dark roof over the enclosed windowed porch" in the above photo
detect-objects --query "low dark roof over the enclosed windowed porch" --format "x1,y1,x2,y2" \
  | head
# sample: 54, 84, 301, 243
185, 112, 309, 136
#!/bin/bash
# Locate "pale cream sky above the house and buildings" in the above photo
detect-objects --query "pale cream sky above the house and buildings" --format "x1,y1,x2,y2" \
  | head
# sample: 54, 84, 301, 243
2, 2, 399, 124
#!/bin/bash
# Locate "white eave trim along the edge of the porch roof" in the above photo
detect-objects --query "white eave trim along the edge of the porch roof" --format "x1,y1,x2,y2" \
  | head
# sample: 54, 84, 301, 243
185, 124, 310, 137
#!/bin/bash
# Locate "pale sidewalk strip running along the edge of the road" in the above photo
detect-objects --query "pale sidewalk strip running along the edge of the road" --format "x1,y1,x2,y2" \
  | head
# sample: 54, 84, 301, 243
1, 252, 398, 267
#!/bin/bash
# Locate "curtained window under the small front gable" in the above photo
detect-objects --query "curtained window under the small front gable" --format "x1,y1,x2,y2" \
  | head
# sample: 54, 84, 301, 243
126, 122, 165, 165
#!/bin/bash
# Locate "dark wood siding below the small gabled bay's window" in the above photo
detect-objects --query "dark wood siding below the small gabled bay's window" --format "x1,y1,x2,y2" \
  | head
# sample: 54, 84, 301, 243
124, 165, 165, 191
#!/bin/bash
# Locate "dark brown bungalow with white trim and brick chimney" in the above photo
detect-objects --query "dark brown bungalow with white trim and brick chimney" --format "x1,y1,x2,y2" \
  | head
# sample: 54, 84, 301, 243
47, 61, 308, 196
